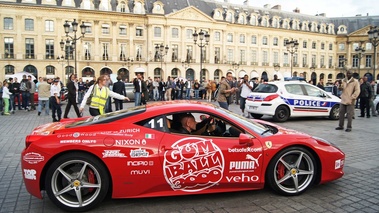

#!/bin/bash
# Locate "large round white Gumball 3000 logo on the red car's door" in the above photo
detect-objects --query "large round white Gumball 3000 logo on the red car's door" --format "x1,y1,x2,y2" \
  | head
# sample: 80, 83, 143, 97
163, 137, 224, 192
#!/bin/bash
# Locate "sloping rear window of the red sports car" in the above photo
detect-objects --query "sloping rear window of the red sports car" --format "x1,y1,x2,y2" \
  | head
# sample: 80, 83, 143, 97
66, 106, 146, 128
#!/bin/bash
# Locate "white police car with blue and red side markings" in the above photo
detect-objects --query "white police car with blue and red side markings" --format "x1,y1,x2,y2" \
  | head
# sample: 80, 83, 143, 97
245, 79, 340, 122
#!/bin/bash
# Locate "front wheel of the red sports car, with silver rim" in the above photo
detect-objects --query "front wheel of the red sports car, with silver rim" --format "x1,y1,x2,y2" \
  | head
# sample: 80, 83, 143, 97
266, 147, 318, 195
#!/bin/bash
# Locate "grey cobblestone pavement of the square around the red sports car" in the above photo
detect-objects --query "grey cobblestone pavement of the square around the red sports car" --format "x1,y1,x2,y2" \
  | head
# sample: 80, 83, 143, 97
0, 100, 379, 213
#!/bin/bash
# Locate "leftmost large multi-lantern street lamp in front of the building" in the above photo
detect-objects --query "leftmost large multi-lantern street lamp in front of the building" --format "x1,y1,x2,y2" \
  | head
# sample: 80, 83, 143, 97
60, 19, 86, 75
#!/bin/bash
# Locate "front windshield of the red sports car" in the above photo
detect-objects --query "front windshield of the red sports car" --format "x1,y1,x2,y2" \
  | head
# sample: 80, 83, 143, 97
216, 107, 273, 136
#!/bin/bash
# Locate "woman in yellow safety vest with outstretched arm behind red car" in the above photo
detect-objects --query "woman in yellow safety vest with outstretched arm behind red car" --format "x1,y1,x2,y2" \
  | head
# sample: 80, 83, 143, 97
79, 75, 130, 116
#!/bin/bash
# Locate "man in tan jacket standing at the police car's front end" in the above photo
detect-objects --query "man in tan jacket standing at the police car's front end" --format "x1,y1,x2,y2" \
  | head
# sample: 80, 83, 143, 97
336, 70, 360, 132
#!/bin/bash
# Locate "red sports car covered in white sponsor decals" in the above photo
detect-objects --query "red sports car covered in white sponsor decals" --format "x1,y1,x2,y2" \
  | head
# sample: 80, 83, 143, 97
21, 101, 345, 211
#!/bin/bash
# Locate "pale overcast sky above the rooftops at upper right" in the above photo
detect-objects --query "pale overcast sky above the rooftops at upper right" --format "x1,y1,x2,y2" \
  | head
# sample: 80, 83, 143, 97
218, 0, 379, 17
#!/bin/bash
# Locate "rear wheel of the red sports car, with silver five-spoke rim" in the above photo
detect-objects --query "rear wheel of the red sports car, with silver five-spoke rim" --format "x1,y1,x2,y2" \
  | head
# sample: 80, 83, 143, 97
45, 152, 109, 212
